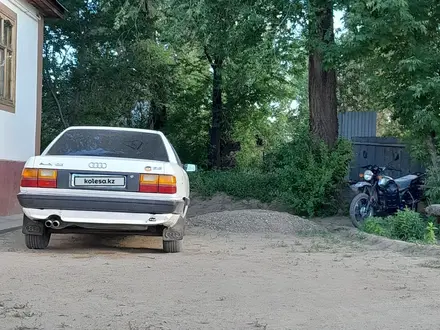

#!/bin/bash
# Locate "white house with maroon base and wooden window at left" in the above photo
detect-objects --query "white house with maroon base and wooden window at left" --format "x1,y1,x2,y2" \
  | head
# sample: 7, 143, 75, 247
0, 0, 64, 216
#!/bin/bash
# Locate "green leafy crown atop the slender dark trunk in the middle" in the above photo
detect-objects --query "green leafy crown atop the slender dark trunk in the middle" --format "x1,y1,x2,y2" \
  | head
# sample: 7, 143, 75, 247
165, 0, 302, 61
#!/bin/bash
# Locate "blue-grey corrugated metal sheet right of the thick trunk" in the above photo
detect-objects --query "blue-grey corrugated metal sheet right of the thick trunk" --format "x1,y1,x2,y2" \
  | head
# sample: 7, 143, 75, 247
338, 112, 377, 140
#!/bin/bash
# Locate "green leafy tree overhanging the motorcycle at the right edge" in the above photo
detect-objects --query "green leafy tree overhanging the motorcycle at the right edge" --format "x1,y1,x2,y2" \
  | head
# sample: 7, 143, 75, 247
344, 0, 440, 199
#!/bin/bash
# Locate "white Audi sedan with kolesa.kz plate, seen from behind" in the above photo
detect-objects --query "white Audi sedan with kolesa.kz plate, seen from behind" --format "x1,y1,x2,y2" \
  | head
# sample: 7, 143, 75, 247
18, 127, 191, 252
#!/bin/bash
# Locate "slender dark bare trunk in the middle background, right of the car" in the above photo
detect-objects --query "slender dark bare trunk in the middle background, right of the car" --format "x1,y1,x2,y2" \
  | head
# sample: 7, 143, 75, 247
208, 59, 223, 169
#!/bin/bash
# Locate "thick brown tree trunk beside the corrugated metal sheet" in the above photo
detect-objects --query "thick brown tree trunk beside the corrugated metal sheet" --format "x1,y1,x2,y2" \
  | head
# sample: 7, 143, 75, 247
309, 0, 338, 147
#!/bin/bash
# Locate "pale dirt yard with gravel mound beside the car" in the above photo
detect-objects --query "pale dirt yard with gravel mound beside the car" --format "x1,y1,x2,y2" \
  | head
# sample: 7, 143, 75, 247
0, 197, 440, 330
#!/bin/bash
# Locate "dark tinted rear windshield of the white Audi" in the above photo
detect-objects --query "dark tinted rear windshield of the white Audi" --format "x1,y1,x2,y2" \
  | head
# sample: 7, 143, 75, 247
46, 129, 168, 162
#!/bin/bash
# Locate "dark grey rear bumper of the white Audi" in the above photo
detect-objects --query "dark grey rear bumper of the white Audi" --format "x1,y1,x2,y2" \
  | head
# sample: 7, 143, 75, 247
17, 193, 188, 217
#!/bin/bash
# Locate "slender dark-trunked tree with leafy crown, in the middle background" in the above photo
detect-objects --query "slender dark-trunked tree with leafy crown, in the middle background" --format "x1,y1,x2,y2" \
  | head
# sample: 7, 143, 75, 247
168, 0, 296, 168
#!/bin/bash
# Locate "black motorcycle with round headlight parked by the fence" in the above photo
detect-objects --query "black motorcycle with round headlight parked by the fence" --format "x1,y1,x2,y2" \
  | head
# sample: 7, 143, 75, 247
350, 161, 425, 228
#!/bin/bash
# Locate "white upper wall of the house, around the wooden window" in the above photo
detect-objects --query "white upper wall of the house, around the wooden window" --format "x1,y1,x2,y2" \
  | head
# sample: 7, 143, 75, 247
0, 0, 38, 161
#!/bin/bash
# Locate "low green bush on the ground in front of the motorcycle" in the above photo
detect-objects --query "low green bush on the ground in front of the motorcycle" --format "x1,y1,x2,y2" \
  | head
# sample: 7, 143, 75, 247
362, 209, 437, 244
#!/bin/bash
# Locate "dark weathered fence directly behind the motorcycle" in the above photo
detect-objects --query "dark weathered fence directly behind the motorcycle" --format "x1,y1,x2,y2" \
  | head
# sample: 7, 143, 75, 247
349, 137, 424, 181
